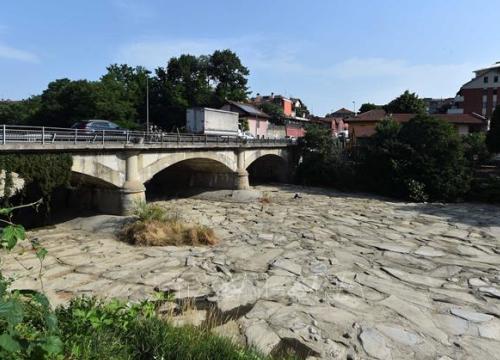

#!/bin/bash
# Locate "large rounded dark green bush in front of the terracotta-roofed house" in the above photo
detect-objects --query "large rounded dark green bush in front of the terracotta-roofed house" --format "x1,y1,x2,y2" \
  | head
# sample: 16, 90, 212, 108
364, 115, 471, 201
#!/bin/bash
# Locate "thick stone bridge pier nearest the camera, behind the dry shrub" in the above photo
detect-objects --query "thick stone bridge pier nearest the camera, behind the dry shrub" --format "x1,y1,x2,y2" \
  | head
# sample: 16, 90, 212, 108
119, 153, 146, 215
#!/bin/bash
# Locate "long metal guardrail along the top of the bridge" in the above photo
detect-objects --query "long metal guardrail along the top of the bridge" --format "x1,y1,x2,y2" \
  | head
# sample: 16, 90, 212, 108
0, 125, 295, 148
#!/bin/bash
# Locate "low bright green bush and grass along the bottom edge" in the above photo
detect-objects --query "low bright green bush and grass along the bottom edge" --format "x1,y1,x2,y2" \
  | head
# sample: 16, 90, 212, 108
57, 298, 278, 360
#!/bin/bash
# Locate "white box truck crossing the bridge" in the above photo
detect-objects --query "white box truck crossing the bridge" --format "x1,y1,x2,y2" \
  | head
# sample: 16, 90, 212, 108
186, 108, 239, 136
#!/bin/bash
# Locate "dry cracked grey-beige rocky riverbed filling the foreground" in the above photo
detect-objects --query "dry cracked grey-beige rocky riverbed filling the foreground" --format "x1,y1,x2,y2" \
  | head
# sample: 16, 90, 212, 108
2, 187, 500, 360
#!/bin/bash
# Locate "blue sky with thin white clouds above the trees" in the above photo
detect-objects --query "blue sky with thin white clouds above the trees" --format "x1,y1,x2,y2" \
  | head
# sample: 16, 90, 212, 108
0, 0, 500, 115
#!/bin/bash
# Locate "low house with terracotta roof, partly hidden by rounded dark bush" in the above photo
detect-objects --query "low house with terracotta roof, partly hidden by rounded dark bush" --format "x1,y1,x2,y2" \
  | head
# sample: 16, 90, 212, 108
345, 109, 487, 138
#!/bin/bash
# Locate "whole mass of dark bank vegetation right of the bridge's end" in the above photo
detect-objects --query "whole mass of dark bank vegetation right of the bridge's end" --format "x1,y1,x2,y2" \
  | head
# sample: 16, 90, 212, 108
297, 110, 500, 201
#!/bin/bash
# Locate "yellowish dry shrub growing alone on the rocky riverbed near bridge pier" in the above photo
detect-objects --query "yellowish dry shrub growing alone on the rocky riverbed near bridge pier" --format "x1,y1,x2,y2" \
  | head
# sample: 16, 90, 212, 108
120, 203, 218, 246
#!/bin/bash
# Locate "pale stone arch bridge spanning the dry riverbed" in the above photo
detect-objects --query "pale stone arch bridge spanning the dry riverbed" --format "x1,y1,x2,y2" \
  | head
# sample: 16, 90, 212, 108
6, 140, 296, 214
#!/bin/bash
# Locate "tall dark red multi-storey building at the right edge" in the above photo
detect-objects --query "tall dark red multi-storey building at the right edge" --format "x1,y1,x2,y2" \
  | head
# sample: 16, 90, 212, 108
449, 61, 500, 119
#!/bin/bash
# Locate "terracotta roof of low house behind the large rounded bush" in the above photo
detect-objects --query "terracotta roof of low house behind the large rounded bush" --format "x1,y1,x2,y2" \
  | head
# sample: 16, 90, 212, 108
345, 109, 486, 125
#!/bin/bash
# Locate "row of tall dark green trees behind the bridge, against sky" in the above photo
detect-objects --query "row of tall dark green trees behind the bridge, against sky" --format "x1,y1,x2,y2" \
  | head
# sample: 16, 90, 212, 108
0, 50, 249, 130
